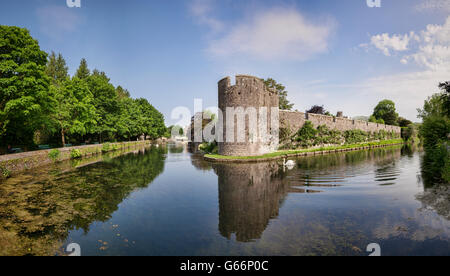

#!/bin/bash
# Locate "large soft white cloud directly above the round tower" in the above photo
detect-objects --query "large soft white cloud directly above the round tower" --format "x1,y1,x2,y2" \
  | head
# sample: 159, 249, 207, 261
208, 9, 335, 61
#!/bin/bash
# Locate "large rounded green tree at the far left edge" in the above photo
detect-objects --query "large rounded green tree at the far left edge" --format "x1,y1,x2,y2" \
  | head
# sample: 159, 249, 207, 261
0, 26, 54, 145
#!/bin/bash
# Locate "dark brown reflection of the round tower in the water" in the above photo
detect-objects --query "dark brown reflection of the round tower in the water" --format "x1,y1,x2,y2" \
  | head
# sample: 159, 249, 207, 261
213, 162, 314, 242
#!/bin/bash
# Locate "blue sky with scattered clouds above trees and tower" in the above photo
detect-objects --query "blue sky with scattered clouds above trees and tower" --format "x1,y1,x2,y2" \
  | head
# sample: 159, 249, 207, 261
0, 0, 450, 124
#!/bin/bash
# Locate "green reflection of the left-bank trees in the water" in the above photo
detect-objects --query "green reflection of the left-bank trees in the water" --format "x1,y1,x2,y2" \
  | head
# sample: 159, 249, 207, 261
0, 148, 167, 255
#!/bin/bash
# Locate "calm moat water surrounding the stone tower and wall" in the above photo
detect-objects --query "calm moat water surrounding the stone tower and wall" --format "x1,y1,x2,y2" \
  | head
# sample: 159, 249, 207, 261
0, 145, 450, 256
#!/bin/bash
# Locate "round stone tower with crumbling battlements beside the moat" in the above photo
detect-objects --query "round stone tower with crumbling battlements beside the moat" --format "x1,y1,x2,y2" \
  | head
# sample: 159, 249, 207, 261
218, 75, 279, 156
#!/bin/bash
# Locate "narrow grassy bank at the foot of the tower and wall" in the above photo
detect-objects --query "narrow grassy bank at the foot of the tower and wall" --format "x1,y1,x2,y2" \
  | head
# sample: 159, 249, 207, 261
205, 139, 403, 161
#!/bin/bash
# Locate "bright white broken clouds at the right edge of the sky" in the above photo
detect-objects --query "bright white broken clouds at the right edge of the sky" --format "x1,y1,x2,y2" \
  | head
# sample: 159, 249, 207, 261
355, 16, 450, 119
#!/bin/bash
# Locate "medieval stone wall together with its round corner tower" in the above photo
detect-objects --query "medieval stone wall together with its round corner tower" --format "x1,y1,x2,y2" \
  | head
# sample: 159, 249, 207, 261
211, 75, 401, 156
